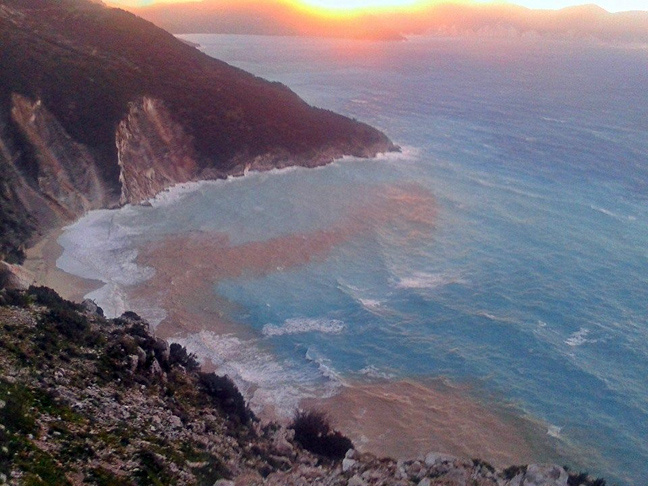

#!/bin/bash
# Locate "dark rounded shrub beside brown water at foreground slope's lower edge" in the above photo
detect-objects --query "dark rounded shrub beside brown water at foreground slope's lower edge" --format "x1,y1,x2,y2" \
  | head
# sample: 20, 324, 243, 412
290, 410, 354, 460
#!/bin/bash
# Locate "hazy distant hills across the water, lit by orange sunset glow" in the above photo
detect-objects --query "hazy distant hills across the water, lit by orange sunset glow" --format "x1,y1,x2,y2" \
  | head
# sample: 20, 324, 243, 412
130, 0, 648, 44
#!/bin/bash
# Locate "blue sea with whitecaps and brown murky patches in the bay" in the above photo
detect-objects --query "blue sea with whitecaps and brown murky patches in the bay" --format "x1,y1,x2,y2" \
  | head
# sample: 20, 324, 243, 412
58, 35, 648, 486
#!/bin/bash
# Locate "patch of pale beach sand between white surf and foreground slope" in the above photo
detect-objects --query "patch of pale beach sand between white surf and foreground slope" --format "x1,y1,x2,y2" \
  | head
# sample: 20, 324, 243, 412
23, 228, 103, 302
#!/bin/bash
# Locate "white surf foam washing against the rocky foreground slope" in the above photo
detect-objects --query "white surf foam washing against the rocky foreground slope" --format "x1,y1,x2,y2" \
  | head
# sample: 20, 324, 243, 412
173, 331, 340, 418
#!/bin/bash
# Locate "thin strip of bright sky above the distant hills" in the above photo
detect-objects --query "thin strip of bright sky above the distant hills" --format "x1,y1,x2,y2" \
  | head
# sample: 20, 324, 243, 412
107, 0, 648, 12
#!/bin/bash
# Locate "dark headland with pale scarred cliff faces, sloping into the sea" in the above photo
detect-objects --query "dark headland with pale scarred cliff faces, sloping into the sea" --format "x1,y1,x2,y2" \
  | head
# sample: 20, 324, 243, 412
0, 0, 395, 260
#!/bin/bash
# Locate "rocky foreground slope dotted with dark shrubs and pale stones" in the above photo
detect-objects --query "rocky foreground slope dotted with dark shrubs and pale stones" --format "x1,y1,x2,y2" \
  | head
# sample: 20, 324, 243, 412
0, 287, 605, 486
